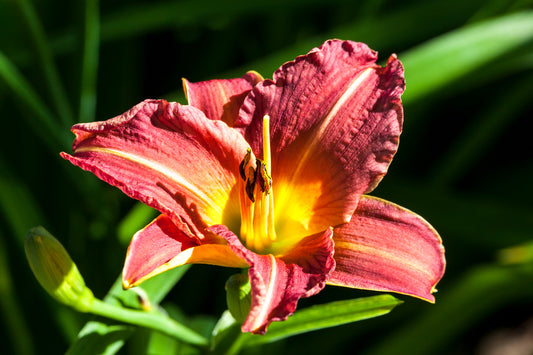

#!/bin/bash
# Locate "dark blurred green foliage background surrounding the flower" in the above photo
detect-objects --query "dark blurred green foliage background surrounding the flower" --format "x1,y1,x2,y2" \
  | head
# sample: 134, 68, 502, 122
0, 0, 533, 354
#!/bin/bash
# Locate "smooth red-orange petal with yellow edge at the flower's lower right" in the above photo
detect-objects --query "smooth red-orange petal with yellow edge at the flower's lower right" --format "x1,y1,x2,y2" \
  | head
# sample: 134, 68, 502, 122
328, 196, 446, 302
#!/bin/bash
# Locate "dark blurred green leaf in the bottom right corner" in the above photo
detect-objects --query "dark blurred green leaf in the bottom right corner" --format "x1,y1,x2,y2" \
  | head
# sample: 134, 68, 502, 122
367, 265, 533, 355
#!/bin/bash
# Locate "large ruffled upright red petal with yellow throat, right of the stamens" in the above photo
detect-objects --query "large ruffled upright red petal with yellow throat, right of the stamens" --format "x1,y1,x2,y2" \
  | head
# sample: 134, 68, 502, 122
239, 40, 405, 238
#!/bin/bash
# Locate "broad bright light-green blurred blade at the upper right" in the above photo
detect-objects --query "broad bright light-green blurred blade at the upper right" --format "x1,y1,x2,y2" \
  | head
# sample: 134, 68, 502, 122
400, 11, 533, 102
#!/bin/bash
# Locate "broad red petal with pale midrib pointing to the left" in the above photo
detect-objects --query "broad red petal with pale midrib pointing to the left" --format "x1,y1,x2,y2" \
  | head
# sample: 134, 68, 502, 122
61, 100, 249, 237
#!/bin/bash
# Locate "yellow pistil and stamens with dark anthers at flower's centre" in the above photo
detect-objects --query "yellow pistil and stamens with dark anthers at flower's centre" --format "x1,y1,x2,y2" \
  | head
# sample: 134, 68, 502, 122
239, 115, 276, 254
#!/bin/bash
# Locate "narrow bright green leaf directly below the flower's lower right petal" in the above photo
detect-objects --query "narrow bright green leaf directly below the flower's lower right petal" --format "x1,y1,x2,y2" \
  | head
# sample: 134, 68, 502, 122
243, 295, 402, 346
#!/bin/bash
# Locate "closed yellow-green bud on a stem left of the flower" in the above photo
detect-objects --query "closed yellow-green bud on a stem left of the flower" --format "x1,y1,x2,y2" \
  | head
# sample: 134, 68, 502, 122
24, 227, 94, 312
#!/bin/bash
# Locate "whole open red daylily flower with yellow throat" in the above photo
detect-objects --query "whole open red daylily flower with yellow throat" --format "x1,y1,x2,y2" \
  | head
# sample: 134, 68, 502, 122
62, 40, 445, 333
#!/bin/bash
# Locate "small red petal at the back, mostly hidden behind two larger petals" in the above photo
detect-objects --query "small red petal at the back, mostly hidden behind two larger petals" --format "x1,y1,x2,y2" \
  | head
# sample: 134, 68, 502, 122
183, 71, 263, 127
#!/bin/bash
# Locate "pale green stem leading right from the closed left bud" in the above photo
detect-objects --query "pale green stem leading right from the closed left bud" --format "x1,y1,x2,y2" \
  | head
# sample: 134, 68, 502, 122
89, 299, 209, 347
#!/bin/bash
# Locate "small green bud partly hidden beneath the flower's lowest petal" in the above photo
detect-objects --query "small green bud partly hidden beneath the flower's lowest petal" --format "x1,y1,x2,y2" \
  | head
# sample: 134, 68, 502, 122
226, 274, 252, 323
